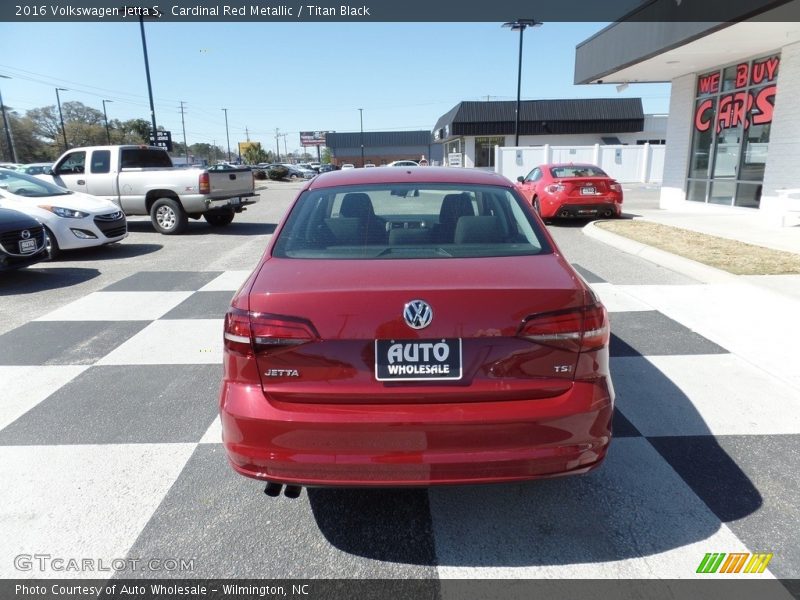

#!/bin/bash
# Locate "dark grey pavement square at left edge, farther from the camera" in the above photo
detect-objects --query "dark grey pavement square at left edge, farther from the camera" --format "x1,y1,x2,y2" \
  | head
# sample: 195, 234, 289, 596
0, 321, 149, 366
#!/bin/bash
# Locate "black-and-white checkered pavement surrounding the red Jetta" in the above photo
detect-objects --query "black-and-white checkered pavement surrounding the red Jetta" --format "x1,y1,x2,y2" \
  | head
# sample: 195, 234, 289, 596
0, 265, 800, 579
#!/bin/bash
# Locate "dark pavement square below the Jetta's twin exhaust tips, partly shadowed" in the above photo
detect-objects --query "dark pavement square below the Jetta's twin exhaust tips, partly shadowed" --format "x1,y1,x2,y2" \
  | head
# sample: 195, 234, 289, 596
126, 444, 436, 579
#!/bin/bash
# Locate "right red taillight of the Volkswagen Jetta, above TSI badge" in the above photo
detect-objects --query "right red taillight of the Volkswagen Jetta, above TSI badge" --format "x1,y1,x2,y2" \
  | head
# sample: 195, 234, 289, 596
519, 304, 611, 352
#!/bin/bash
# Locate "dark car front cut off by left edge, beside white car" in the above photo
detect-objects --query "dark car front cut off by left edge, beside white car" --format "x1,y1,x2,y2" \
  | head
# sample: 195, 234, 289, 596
0, 207, 48, 271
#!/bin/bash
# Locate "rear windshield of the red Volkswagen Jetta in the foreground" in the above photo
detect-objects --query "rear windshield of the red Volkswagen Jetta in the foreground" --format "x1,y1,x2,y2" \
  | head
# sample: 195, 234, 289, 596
273, 184, 552, 259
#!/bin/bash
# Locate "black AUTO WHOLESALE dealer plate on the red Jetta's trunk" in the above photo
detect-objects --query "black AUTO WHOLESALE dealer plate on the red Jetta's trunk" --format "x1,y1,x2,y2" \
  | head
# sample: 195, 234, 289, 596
375, 338, 462, 381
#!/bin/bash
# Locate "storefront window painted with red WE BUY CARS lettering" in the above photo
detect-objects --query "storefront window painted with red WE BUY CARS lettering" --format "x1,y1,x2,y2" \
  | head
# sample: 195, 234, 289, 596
686, 55, 780, 208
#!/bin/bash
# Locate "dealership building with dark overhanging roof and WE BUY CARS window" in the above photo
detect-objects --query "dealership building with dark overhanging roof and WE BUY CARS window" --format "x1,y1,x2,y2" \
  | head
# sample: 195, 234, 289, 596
575, 0, 800, 224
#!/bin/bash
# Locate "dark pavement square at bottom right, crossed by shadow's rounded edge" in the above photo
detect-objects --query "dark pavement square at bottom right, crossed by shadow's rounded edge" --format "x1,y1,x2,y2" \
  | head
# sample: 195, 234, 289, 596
648, 434, 800, 579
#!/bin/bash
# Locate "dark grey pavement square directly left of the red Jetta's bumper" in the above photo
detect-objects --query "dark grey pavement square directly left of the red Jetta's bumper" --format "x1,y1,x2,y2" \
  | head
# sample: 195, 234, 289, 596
0, 365, 221, 446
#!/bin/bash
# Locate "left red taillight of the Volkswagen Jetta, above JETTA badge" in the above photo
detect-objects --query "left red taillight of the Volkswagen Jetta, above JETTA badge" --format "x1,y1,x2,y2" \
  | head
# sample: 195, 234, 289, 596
224, 308, 317, 355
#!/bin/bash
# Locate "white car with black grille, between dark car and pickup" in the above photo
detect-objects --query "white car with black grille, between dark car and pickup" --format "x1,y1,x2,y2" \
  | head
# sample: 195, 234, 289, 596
0, 169, 128, 256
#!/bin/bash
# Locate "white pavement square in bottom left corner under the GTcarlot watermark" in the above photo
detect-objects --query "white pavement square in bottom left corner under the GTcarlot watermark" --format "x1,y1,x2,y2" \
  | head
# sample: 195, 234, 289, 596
0, 444, 195, 579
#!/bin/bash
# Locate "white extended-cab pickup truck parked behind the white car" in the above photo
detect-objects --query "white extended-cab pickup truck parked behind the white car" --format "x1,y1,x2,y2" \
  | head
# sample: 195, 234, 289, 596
37, 146, 257, 235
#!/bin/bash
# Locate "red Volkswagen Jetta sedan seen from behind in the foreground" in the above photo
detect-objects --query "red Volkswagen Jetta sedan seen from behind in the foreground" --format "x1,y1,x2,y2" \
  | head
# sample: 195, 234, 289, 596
220, 168, 614, 496
